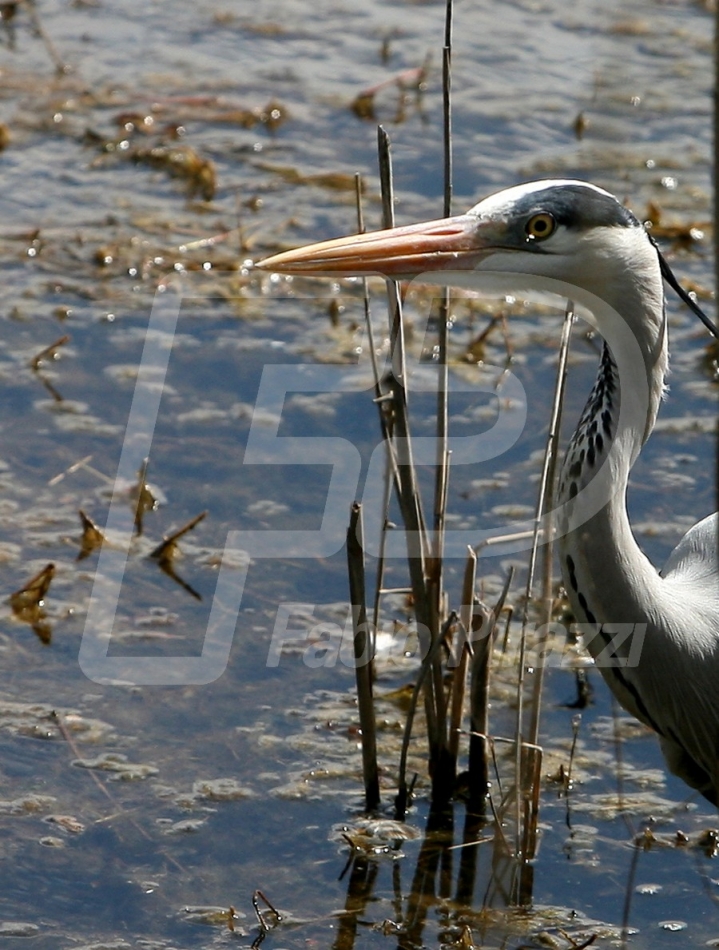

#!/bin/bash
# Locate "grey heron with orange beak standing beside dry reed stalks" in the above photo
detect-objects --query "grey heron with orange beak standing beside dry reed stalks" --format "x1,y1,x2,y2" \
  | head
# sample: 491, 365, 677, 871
257, 180, 719, 804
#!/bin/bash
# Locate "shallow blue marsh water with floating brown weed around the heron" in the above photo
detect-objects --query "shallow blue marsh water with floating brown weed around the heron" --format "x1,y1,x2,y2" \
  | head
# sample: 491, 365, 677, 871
0, 0, 719, 950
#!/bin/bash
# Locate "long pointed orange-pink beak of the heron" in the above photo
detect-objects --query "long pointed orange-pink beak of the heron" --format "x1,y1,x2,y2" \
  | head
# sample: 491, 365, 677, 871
255, 214, 502, 280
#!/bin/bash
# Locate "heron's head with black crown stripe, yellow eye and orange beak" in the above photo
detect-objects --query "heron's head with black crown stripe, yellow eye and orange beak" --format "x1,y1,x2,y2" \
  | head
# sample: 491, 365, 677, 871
257, 180, 663, 318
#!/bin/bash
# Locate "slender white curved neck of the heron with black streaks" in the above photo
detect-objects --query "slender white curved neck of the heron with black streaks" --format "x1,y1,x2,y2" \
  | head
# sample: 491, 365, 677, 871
558, 290, 667, 623
